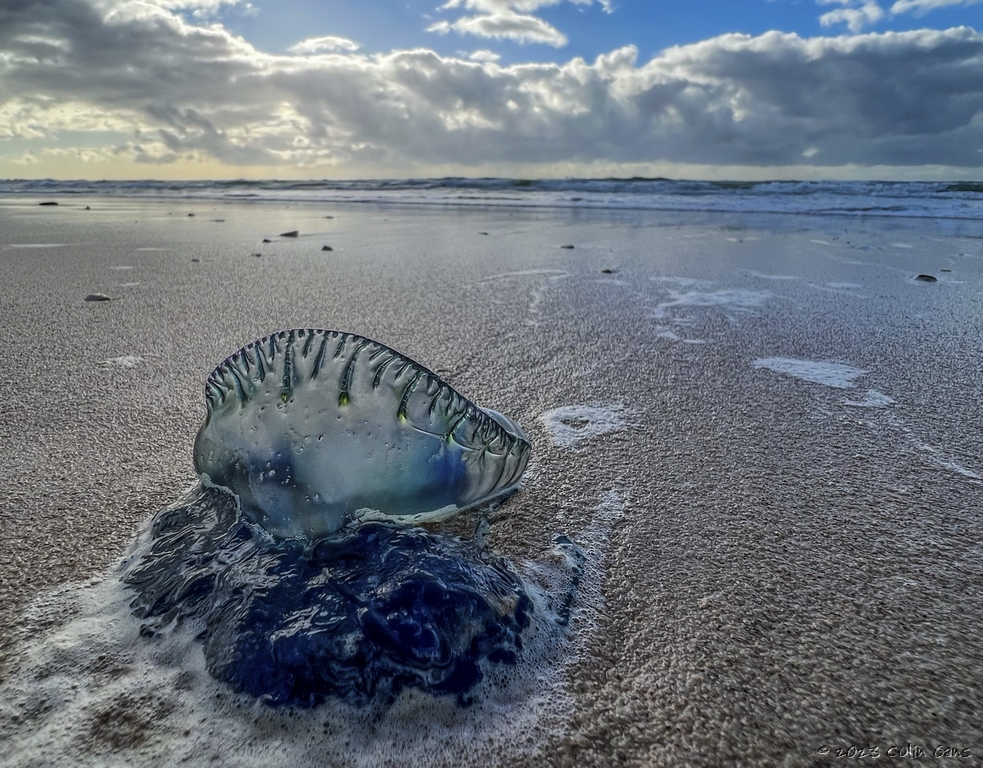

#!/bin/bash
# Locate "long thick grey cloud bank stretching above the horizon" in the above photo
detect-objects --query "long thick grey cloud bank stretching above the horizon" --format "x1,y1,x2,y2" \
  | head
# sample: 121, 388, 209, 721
0, 0, 983, 173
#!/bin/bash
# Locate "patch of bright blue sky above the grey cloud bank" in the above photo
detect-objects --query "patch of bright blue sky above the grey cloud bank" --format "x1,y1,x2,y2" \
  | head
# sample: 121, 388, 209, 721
211, 0, 983, 64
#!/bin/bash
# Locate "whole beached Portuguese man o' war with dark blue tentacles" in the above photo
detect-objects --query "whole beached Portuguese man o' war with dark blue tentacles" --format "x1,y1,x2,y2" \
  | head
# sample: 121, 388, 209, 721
123, 330, 533, 706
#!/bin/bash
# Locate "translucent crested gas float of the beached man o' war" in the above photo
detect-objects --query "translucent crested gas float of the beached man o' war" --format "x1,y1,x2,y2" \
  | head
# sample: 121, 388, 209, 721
194, 329, 530, 538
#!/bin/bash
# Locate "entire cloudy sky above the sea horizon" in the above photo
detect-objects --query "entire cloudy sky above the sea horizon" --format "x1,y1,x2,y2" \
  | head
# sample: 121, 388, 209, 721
0, 0, 983, 179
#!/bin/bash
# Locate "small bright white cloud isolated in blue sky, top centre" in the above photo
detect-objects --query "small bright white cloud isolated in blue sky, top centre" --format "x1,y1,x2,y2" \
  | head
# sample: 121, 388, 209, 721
427, 0, 613, 48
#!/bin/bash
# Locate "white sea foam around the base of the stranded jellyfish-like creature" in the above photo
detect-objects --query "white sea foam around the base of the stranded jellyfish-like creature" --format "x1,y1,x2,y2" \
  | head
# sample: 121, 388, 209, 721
0, 520, 573, 768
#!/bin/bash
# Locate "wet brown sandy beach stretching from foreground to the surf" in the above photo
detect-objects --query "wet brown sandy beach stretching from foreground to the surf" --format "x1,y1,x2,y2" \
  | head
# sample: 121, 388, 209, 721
0, 198, 983, 767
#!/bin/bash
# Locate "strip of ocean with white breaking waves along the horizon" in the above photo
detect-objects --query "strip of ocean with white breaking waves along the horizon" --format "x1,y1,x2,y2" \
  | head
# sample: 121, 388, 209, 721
0, 177, 983, 219
